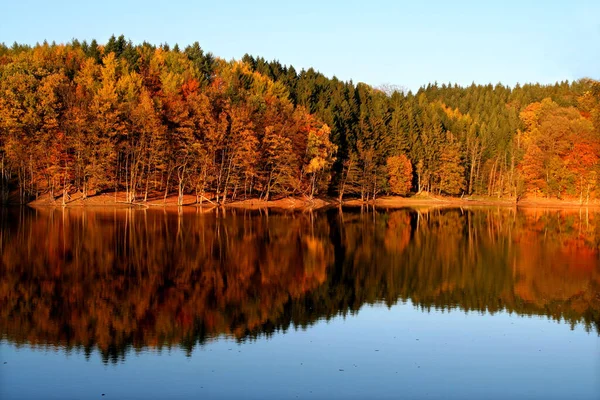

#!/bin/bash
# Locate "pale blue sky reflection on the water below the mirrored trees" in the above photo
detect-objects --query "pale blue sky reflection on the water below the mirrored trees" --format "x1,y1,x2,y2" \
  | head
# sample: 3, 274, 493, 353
0, 304, 600, 400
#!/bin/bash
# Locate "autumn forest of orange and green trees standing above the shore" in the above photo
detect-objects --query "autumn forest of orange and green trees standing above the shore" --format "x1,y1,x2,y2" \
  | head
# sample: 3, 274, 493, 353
0, 35, 600, 205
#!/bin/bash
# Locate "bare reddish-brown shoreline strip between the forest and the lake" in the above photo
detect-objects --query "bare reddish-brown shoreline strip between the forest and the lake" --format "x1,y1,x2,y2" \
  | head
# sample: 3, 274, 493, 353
8, 192, 600, 210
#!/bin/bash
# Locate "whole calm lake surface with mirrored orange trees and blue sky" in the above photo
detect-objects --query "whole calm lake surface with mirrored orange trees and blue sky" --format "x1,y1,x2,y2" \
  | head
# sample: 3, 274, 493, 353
0, 208, 600, 400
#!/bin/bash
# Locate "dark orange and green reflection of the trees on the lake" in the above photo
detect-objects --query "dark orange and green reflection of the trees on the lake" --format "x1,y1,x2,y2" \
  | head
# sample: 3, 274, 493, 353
0, 208, 600, 362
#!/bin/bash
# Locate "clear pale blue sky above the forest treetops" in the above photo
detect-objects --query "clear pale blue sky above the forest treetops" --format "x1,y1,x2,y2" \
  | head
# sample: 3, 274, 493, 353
0, 0, 600, 89
